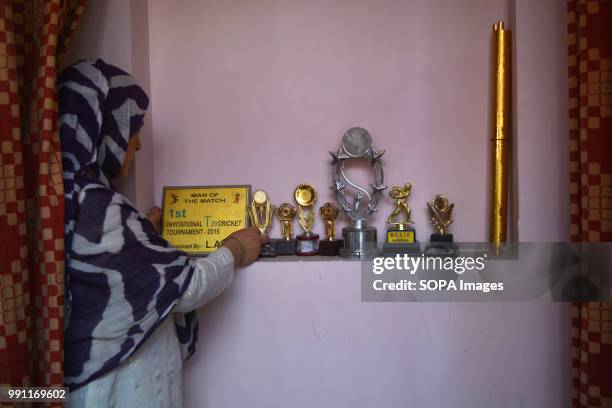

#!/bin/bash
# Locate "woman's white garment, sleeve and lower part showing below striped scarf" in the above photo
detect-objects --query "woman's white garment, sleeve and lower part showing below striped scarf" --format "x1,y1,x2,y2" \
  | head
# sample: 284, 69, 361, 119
67, 247, 234, 408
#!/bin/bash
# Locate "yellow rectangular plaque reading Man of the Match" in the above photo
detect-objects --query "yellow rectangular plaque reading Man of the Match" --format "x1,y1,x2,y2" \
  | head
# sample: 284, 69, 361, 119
161, 186, 251, 255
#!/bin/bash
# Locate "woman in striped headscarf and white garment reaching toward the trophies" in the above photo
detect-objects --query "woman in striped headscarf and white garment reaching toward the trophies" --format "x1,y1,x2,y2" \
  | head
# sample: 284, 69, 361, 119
58, 60, 267, 407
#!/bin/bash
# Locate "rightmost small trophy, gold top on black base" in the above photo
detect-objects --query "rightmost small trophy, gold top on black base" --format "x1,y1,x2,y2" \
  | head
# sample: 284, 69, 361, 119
425, 194, 458, 256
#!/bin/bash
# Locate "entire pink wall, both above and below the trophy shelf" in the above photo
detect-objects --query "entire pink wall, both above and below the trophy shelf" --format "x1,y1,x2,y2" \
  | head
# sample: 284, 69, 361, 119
149, 0, 570, 407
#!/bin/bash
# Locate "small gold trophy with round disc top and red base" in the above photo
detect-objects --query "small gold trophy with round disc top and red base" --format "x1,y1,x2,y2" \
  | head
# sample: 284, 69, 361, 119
294, 184, 319, 256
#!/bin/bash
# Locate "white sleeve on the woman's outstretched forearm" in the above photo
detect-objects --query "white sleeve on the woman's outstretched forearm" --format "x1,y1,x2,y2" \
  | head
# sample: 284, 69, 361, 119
173, 247, 234, 313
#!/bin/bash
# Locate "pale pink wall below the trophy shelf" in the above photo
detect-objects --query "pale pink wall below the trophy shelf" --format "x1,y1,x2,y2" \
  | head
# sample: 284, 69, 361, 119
183, 261, 571, 408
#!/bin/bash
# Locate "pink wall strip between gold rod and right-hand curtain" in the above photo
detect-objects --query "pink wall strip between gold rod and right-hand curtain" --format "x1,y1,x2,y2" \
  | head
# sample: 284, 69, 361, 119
515, 0, 569, 241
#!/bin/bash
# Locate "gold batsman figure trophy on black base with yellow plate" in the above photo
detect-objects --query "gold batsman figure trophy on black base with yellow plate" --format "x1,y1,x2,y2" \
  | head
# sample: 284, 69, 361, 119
383, 183, 421, 255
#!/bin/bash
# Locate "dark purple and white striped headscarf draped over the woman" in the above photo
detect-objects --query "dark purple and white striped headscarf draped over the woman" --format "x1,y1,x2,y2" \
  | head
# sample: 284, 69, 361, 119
58, 59, 197, 390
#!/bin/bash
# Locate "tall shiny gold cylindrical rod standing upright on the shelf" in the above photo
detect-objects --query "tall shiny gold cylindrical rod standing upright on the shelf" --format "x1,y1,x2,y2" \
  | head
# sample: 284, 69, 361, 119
489, 21, 511, 245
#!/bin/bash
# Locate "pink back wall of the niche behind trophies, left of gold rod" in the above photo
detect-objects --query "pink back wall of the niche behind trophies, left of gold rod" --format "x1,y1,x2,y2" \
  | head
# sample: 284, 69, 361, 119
150, 0, 505, 241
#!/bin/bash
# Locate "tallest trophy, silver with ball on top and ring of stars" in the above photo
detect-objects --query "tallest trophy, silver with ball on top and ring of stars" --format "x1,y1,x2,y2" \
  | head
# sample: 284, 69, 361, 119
330, 127, 387, 259
